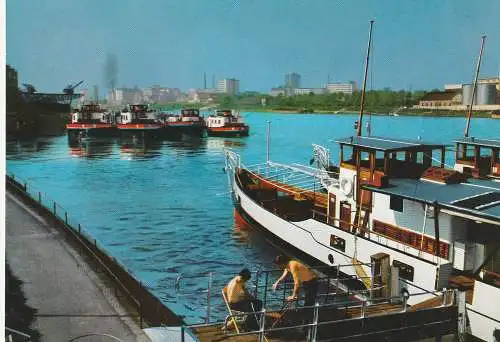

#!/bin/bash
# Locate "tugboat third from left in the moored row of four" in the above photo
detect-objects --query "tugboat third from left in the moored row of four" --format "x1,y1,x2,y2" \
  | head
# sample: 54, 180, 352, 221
164, 109, 205, 137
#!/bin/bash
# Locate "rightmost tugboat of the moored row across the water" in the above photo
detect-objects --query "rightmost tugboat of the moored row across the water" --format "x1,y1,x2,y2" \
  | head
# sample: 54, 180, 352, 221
205, 109, 249, 137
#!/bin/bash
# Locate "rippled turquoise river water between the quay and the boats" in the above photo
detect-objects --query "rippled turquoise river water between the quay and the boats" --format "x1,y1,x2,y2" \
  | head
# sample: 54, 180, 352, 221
7, 113, 500, 322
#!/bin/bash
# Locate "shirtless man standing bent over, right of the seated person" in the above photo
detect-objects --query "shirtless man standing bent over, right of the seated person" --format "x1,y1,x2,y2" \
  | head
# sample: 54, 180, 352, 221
273, 255, 318, 306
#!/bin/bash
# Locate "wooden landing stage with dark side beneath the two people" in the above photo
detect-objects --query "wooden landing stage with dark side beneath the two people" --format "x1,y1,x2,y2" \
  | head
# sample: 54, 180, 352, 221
191, 296, 458, 342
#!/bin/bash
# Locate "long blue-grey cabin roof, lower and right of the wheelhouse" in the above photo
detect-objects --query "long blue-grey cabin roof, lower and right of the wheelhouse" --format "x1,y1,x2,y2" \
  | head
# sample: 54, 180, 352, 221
362, 178, 500, 225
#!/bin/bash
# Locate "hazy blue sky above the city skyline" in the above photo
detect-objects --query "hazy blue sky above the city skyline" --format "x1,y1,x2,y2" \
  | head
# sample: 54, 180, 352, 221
6, 0, 500, 92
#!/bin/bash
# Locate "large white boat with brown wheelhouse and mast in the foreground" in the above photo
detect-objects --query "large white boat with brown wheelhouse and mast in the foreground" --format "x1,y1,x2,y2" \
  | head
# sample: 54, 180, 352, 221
225, 24, 500, 341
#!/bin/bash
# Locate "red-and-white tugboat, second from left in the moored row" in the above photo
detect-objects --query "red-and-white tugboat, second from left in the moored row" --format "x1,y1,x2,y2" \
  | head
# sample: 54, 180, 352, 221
118, 104, 163, 136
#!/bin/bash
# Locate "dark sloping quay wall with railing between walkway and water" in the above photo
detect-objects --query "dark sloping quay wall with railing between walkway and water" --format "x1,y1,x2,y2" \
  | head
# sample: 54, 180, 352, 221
5, 175, 185, 327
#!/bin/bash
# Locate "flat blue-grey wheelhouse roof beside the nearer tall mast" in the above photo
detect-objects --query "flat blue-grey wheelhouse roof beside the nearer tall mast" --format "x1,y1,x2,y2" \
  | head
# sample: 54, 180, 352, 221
335, 136, 445, 152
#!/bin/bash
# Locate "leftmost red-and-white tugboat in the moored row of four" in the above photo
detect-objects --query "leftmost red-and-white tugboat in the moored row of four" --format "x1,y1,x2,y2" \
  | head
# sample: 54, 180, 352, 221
66, 103, 117, 139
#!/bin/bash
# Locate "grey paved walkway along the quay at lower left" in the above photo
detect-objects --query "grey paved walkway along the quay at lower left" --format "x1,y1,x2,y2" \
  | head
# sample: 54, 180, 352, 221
5, 192, 150, 342
